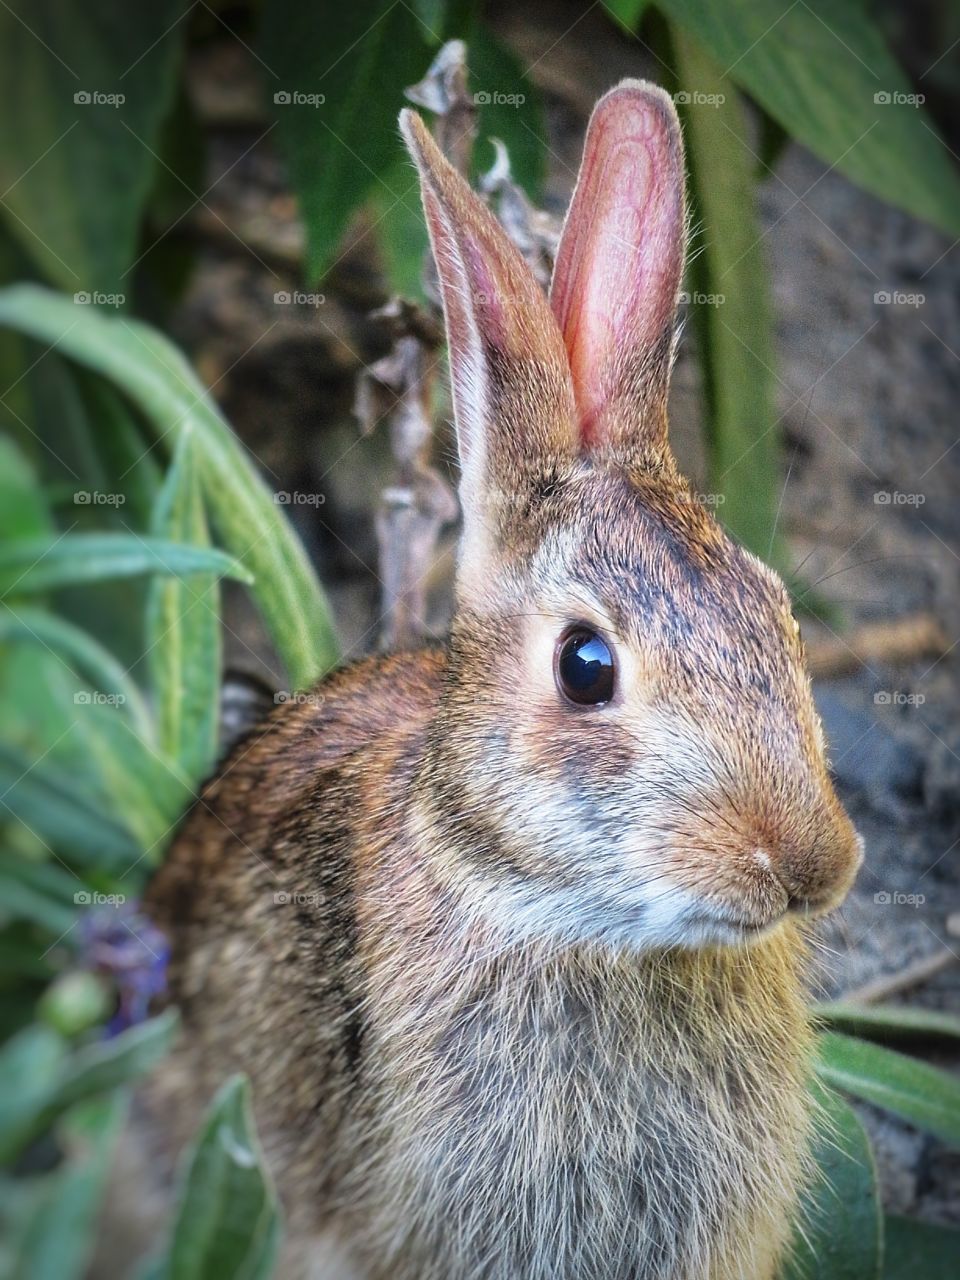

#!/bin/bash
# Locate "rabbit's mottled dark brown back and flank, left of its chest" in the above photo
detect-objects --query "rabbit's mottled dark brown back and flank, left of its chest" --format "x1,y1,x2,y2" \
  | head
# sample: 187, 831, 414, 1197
146, 650, 444, 1225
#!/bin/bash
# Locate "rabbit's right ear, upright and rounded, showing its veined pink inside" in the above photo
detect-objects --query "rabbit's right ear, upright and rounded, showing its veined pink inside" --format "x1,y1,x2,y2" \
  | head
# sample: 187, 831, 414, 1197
550, 81, 685, 461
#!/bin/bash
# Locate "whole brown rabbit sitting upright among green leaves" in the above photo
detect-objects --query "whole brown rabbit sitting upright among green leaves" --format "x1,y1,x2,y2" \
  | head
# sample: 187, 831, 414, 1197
142, 81, 860, 1280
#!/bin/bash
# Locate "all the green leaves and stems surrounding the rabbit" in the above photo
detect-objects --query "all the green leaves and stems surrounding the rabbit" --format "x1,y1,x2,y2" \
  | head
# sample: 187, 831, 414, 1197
0, 0, 960, 1280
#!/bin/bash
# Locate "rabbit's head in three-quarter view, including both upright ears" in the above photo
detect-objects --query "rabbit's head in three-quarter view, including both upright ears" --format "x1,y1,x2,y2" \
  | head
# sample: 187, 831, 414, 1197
401, 81, 860, 947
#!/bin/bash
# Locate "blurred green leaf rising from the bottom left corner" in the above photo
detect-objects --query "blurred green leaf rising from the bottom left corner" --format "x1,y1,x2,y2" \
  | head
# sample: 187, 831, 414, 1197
8, 1094, 129, 1280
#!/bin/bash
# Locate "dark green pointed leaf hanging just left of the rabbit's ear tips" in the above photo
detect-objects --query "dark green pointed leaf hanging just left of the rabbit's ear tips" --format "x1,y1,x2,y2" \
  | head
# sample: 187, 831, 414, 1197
261, 0, 431, 280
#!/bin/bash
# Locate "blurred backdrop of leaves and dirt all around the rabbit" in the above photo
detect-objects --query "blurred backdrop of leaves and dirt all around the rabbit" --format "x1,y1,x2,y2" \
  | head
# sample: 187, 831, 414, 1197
0, 0, 960, 1280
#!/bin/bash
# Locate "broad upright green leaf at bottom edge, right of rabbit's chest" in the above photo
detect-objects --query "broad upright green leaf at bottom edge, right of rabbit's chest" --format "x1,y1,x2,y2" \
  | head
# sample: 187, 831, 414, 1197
781, 1088, 883, 1280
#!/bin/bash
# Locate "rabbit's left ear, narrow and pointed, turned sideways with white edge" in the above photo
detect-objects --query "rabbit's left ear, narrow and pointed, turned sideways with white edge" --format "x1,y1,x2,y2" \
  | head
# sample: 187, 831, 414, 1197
401, 110, 577, 525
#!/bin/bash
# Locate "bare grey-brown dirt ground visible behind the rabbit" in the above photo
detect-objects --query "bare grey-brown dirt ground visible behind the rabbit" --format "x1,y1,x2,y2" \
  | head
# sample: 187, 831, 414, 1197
167, 6, 960, 1221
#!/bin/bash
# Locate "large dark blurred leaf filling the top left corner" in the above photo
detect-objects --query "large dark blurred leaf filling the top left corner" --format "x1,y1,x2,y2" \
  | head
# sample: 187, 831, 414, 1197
0, 0, 186, 294
